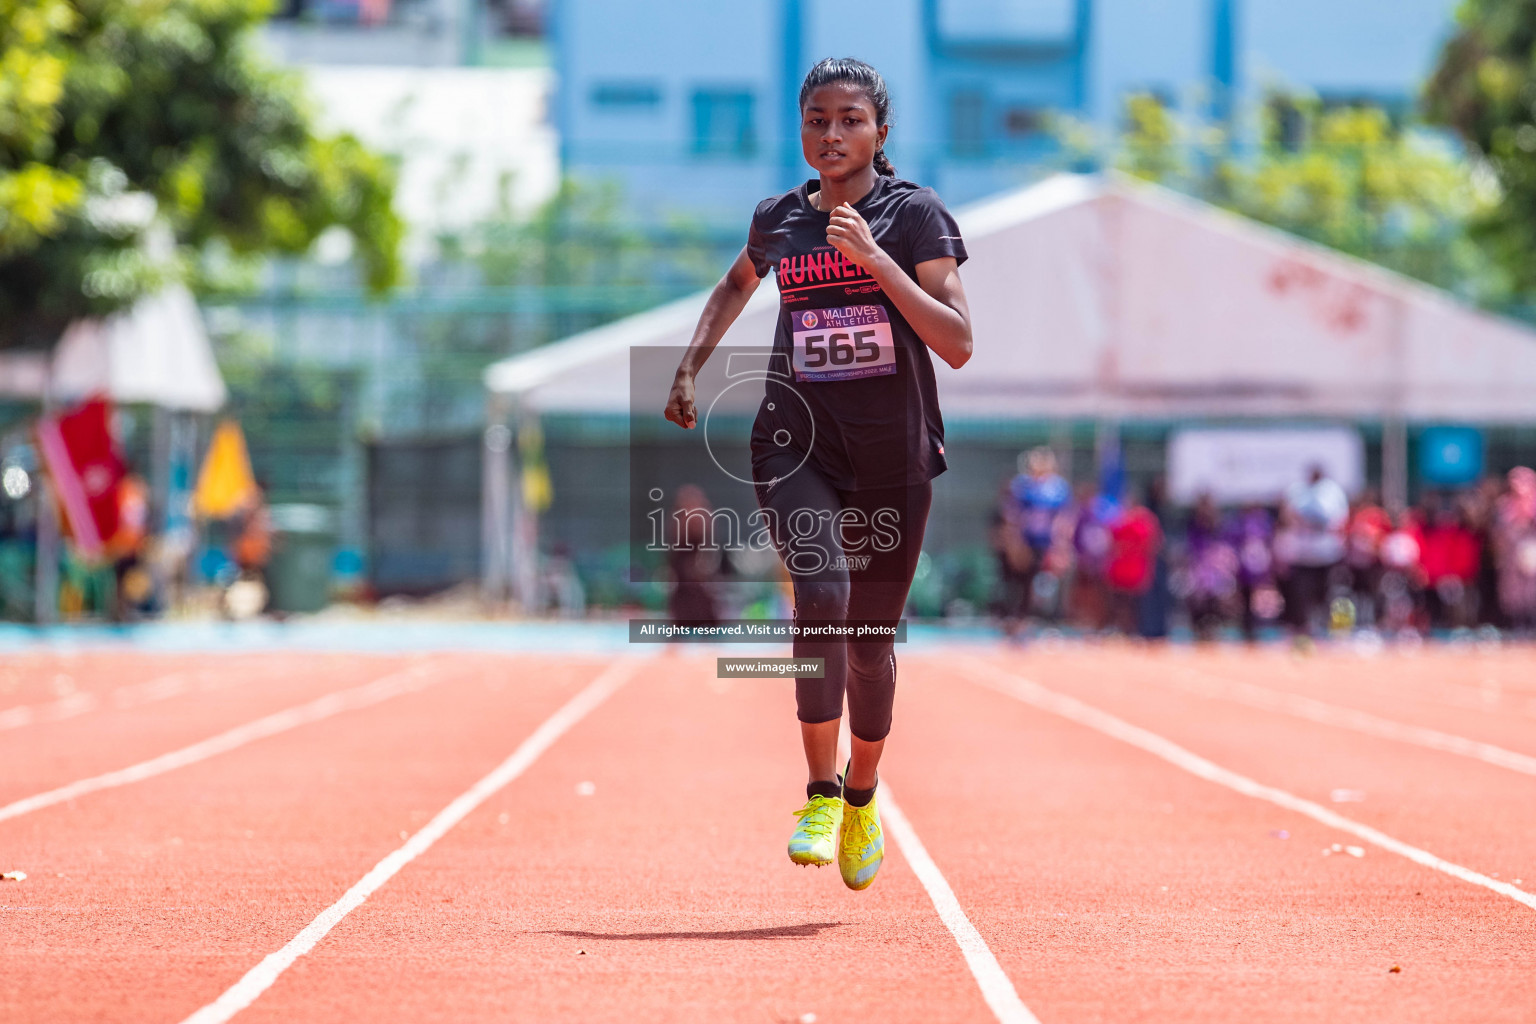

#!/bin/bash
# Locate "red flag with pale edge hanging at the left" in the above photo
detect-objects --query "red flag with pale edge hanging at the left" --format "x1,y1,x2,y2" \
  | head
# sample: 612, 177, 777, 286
37, 398, 124, 559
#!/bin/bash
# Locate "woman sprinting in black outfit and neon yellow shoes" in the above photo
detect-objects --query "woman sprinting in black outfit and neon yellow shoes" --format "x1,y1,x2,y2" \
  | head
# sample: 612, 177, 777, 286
665, 58, 971, 889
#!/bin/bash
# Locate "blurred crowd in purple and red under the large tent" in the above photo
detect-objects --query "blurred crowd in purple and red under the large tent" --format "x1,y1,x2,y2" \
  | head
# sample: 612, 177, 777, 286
992, 448, 1536, 640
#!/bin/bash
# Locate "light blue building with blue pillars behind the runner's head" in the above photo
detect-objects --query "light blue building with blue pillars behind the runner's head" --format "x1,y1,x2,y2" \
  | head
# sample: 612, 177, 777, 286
551, 0, 1455, 223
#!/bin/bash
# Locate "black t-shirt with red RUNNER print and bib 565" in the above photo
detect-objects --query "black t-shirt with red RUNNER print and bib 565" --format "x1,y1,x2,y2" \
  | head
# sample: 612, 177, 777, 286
746, 175, 966, 491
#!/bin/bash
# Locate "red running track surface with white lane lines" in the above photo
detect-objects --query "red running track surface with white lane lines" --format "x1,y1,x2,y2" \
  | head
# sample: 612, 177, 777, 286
0, 646, 1536, 1024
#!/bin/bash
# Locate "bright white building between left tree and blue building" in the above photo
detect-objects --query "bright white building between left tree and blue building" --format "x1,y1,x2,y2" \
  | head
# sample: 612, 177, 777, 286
263, 0, 559, 237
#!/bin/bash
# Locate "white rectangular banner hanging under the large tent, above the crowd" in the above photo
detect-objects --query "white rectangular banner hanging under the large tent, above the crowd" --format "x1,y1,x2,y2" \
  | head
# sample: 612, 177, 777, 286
1167, 427, 1366, 505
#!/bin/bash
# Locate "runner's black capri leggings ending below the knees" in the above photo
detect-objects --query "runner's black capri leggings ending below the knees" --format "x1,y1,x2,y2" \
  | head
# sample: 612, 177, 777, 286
753, 450, 934, 743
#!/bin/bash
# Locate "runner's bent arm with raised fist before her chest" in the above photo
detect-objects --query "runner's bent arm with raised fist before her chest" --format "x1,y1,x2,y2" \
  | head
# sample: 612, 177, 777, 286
826, 203, 971, 370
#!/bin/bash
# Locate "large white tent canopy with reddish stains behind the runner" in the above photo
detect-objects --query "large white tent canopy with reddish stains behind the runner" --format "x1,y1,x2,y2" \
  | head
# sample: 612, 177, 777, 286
485, 175, 1536, 422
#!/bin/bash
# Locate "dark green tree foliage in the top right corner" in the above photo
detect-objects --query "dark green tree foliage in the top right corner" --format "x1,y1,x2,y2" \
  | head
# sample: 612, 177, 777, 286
1424, 0, 1536, 298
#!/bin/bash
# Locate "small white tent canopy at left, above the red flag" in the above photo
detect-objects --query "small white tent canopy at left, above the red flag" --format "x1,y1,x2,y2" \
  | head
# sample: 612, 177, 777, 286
0, 286, 229, 413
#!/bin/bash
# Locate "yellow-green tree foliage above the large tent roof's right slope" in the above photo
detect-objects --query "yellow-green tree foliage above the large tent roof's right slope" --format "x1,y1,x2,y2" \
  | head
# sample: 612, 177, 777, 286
1093, 95, 1507, 301
